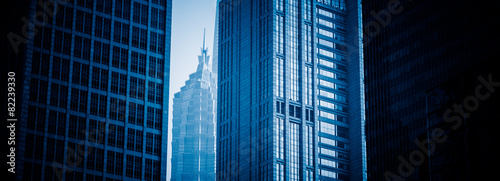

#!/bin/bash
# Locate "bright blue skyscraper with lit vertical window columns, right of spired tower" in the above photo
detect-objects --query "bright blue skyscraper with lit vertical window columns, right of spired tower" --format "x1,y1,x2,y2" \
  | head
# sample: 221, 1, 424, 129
217, 0, 366, 180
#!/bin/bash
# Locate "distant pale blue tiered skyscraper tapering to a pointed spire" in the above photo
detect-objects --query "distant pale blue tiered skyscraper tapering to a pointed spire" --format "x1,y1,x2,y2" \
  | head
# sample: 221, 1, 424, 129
171, 32, 217, 181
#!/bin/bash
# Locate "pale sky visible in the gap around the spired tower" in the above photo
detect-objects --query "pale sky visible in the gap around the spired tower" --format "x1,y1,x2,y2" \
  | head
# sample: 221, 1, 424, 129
167, 0, 217, 181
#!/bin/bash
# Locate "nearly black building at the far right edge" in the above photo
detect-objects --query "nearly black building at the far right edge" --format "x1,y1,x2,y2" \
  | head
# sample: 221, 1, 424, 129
363, 0, 500, 181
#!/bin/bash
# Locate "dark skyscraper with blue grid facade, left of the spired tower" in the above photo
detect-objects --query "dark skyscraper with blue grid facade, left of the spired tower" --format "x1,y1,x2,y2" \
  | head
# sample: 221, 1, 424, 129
12, 0, 172, 180
